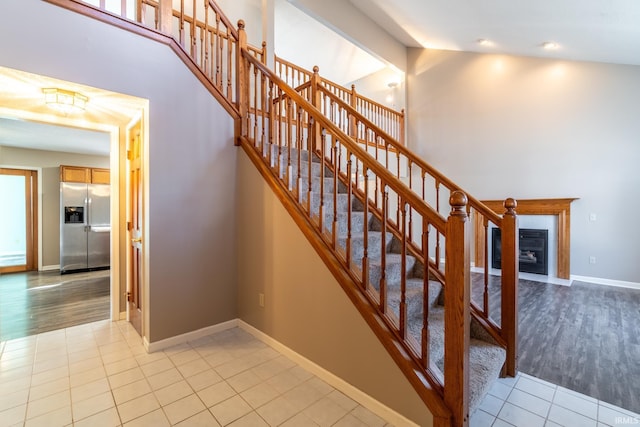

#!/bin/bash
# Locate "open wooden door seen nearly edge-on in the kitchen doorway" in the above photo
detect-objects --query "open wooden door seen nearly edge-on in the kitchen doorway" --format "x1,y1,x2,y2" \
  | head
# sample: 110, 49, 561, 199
127, 121, 144, 336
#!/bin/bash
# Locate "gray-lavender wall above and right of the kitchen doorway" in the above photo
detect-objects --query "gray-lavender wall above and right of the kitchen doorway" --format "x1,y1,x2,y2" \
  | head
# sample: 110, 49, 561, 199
0, 0, 237, 342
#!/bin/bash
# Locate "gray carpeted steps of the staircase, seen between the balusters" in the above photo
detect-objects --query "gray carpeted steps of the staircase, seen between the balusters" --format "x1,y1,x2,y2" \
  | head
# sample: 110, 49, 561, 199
278, 146, 506, 413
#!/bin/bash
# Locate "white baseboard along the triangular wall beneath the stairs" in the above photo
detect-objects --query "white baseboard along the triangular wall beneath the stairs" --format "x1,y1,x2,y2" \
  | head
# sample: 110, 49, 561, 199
238, 319, 419, 427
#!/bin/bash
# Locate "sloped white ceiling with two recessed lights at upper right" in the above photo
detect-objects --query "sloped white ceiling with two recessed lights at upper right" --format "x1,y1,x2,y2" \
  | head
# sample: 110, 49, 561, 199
349, 0, 640, 65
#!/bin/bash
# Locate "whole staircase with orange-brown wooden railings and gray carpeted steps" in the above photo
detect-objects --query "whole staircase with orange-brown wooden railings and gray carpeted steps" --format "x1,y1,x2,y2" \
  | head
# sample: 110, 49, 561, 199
46, 0, 517, 427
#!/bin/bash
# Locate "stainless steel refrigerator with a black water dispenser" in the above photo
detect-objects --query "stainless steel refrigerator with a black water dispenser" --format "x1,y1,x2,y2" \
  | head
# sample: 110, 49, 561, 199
60, 182, 111, 274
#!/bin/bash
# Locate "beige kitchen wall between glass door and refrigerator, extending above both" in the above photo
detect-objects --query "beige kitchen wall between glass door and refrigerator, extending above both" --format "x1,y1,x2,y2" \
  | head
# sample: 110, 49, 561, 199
0, 147, 109, 268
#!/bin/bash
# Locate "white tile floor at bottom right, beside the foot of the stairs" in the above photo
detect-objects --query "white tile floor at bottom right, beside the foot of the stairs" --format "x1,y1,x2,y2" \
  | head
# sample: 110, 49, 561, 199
470, 373, 640, 427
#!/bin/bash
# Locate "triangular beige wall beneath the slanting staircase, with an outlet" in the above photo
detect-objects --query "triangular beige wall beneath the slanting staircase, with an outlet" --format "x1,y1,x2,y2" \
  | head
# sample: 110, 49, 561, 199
236, 151, 432, 426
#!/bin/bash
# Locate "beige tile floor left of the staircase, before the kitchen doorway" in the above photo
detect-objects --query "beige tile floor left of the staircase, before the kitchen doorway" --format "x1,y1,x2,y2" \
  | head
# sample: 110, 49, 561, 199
0, 321, 396, 427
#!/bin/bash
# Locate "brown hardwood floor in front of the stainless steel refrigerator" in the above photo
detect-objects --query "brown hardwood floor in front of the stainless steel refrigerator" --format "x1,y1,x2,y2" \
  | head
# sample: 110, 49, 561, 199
0, 270, 111, 341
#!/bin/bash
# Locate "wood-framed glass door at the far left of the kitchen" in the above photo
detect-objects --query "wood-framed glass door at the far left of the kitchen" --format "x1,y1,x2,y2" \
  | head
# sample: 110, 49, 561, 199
0, 168, 38, 273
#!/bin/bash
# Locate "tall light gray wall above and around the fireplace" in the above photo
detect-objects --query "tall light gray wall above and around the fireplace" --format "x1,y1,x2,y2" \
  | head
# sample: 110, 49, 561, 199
407, 49, 640, 282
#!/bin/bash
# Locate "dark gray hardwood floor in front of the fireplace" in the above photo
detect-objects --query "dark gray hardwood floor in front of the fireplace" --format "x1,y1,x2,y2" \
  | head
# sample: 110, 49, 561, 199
472, 273, 640, 413
